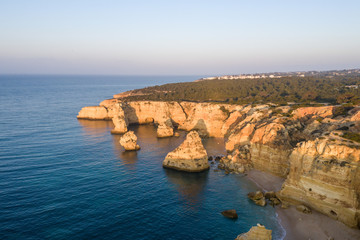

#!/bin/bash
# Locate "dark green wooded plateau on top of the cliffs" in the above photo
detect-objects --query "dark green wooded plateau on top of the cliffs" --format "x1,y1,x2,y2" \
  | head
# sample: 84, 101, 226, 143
119, 76, 360, 105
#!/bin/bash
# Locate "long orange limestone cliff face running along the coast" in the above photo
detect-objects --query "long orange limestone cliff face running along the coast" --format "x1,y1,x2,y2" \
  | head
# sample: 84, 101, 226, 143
78, 99, 360, 226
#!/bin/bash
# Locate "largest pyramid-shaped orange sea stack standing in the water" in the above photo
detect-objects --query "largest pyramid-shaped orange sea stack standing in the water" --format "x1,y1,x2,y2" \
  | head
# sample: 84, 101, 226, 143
163, 131, 210, 172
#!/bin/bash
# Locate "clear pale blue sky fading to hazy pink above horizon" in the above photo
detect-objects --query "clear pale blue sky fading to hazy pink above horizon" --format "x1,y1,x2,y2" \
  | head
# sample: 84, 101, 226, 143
0, 0, 360, 75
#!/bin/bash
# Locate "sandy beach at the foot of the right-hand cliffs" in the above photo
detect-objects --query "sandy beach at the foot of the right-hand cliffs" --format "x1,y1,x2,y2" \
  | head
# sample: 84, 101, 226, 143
247, 170, 360, 240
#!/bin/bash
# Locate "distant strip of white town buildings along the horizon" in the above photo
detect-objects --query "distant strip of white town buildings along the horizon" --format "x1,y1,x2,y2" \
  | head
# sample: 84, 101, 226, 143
196, 69, 360, 82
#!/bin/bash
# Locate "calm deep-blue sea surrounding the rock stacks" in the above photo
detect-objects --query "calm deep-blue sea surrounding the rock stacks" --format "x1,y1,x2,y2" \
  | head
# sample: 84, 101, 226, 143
0, 76, 283, 239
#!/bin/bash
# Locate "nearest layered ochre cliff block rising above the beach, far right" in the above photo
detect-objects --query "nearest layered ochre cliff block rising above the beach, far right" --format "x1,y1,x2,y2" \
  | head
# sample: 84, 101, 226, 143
279, 137, 360, 227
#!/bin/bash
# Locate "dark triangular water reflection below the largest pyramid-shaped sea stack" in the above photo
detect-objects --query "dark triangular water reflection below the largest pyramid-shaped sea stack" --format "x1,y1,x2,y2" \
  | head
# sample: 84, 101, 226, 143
163, 168, 209, 209
